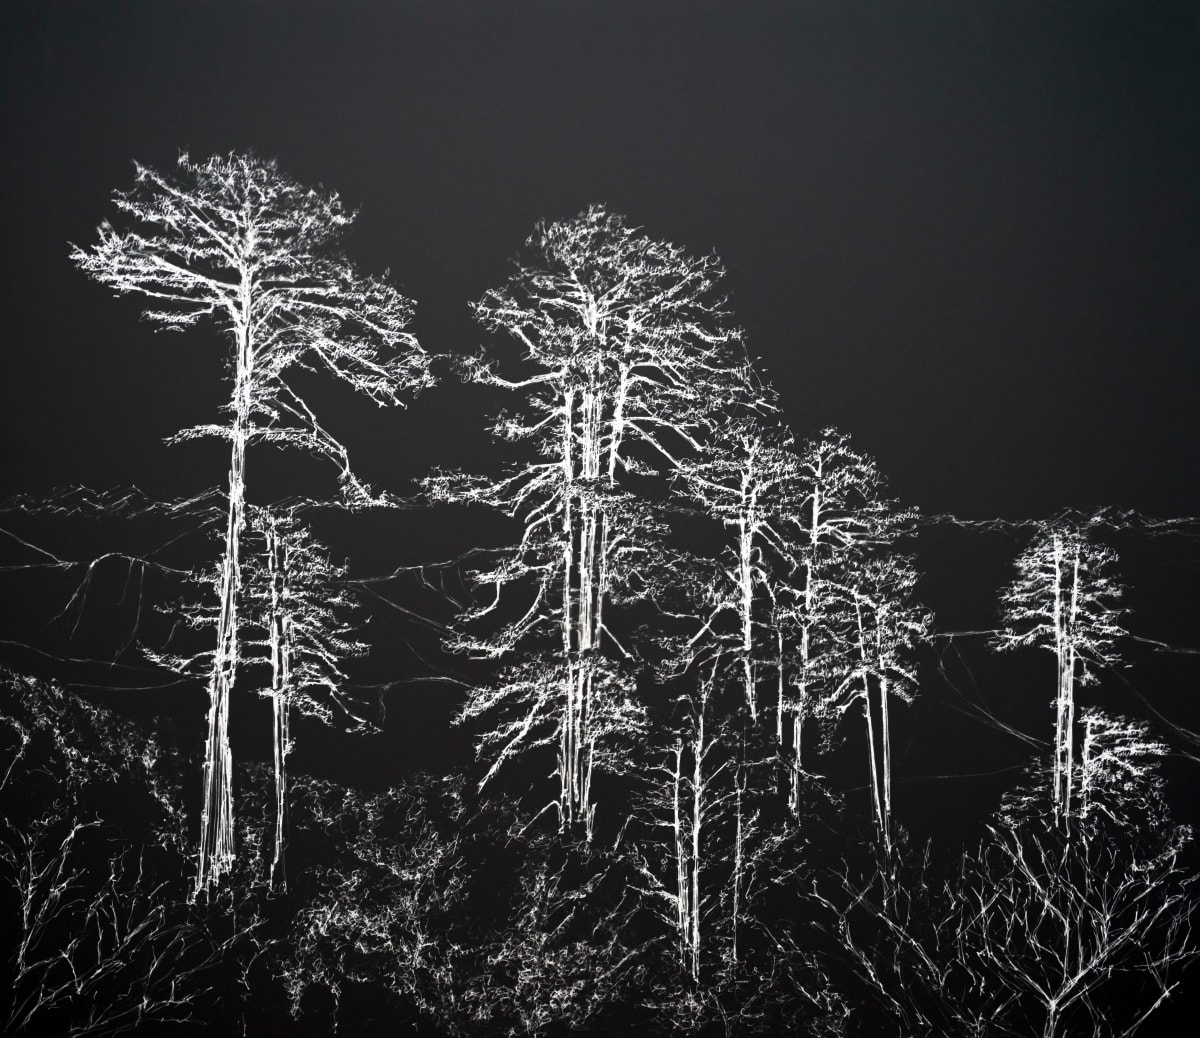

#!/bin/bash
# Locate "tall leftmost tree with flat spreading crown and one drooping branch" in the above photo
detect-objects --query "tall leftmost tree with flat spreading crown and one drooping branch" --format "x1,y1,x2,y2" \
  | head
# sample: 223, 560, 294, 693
71, 155, 431, 893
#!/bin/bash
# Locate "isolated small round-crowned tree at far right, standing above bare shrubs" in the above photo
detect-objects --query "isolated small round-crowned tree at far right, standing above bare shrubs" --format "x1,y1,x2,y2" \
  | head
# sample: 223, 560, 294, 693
992, 526, 1122, 828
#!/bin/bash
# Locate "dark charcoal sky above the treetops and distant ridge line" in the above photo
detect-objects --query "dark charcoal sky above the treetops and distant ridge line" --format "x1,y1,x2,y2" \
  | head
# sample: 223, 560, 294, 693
0, 0, 1200, 516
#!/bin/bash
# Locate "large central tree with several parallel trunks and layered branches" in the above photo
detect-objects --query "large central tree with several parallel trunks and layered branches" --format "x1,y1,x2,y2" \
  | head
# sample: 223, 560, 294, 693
426, 206, 755, 836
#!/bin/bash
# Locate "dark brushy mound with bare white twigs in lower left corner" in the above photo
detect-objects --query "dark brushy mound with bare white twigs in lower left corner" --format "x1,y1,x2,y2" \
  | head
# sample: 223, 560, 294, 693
0, 672, 254, 1034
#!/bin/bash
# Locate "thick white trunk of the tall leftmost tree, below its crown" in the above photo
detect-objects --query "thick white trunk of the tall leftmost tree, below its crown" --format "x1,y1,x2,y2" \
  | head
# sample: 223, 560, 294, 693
196, 307, 252, 895
